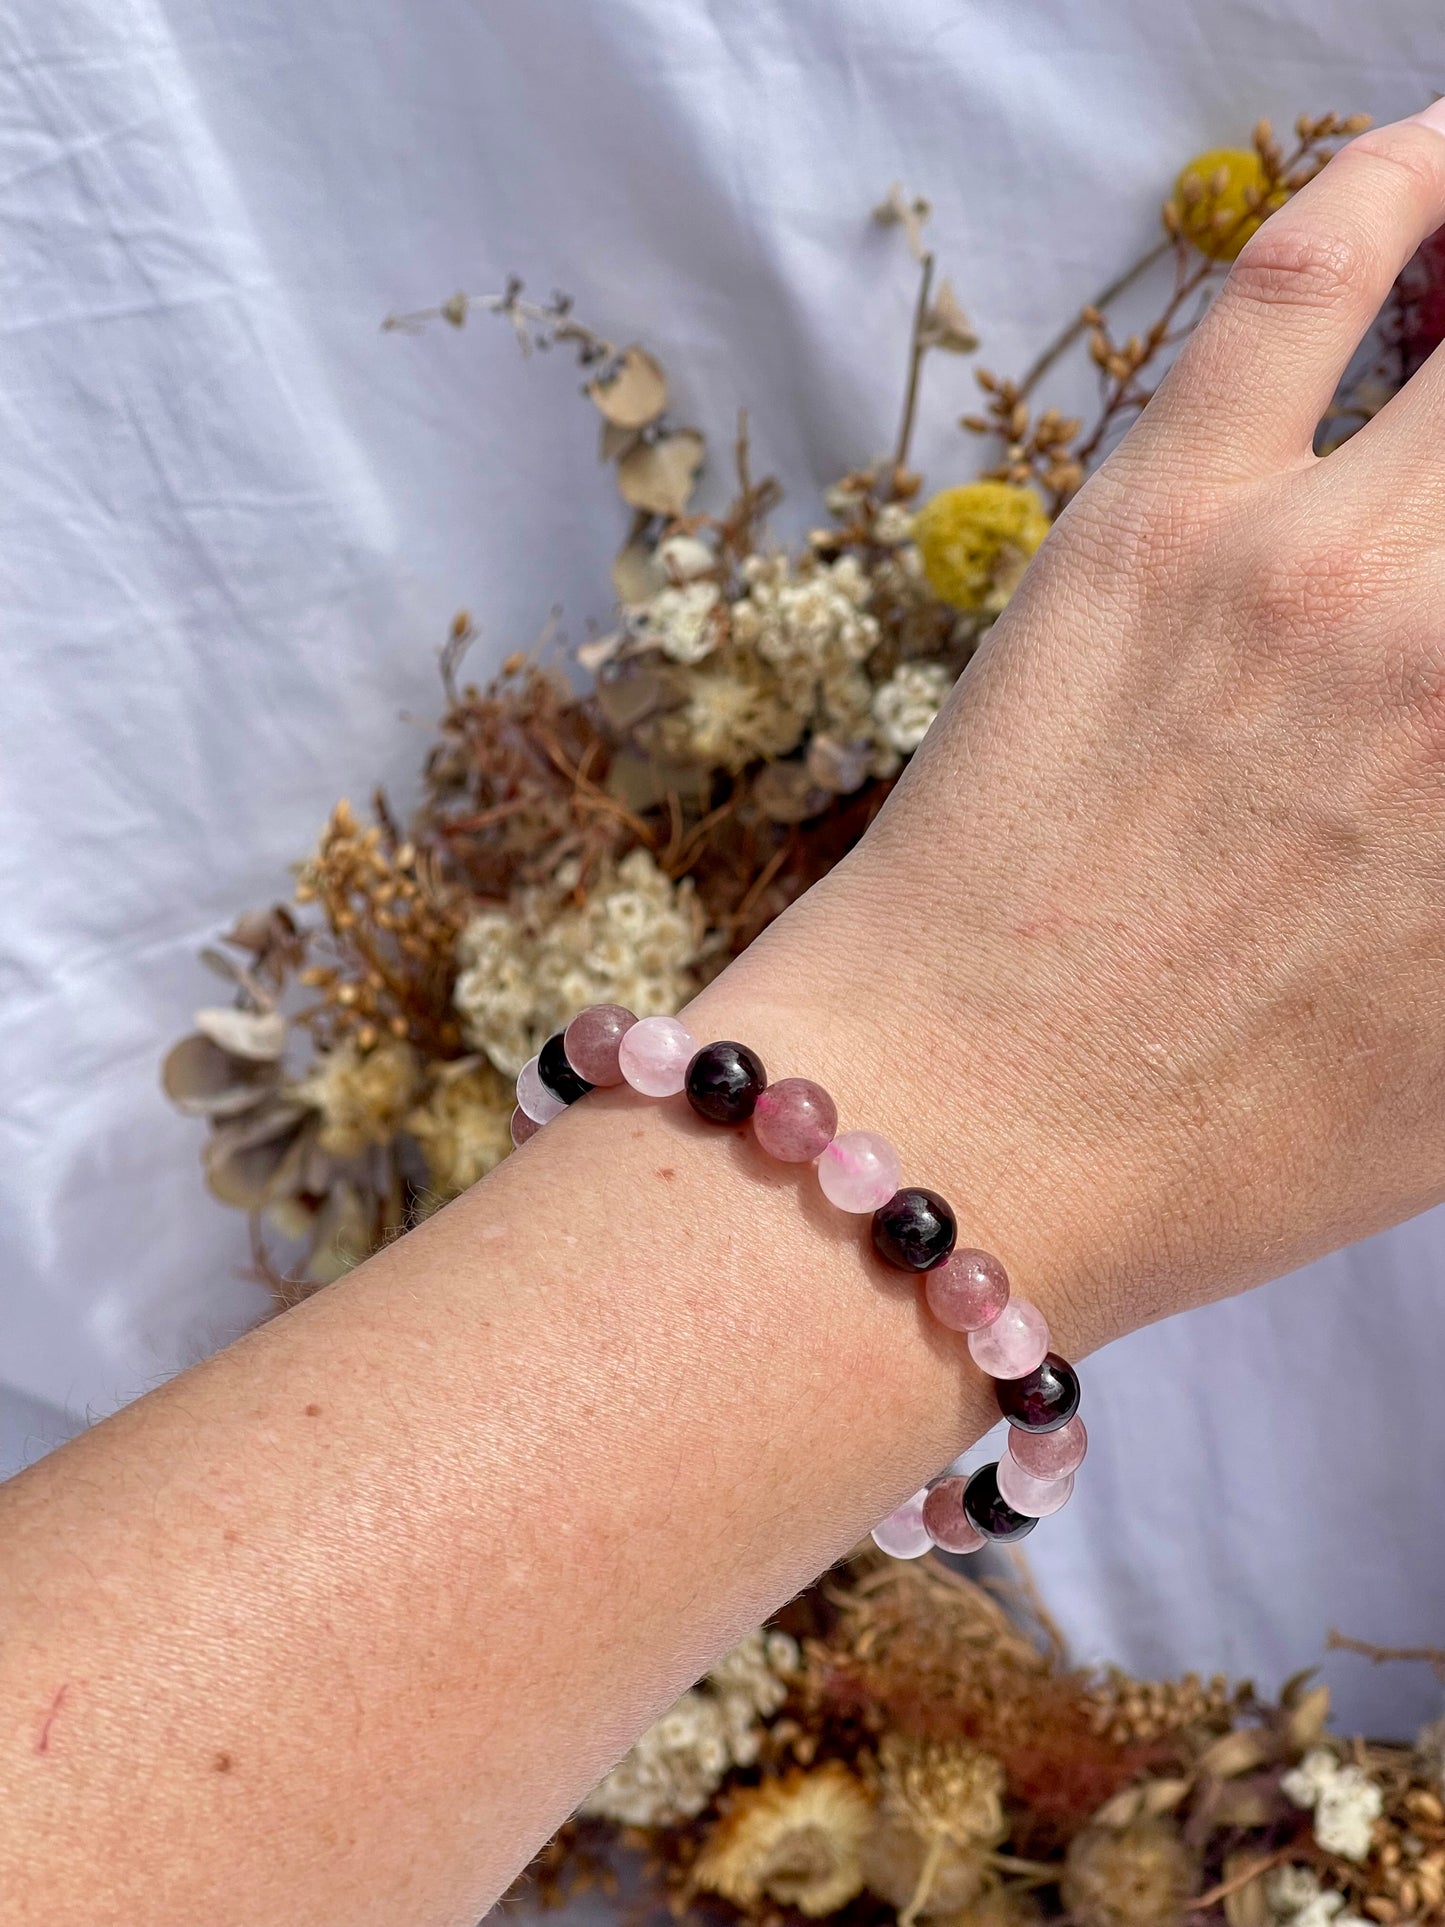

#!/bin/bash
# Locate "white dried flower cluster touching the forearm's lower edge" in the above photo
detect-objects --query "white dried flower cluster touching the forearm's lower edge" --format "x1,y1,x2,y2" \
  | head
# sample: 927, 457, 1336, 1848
578, 1632, 798, 1827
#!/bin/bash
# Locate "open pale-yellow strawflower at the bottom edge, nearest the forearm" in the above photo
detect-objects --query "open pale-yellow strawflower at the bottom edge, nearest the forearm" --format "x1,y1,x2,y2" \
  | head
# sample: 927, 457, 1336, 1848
692, 1759, 873, 1919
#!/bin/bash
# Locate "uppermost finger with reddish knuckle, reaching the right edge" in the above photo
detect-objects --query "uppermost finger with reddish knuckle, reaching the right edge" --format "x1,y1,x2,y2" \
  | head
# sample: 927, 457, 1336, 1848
1146, 100, 1445, 474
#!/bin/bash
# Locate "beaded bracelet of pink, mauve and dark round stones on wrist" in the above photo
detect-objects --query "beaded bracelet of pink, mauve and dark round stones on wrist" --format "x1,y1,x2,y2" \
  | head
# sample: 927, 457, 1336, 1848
512, 1004, 1089, 1559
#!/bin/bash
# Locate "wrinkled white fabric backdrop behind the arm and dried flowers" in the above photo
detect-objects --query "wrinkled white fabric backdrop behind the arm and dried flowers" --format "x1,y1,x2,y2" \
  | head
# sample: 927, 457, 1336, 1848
0, 0, 1445, 1729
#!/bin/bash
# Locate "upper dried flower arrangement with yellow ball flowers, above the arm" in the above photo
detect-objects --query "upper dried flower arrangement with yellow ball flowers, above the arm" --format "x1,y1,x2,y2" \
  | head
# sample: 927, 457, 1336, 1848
164, 114, 1418, 1303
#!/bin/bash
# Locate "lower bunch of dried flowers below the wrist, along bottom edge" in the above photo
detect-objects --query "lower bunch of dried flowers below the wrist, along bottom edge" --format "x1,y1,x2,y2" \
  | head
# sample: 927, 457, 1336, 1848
516, 1547, 1445, 1927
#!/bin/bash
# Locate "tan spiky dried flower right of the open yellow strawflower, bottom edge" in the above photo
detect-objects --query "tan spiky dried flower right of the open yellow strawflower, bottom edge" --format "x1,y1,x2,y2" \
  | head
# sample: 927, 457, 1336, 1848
863, 1732, 1008, 1927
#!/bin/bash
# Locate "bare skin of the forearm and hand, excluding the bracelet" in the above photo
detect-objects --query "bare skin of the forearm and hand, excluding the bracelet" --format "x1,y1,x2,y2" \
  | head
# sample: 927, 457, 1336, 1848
0, 101, 1445, 1927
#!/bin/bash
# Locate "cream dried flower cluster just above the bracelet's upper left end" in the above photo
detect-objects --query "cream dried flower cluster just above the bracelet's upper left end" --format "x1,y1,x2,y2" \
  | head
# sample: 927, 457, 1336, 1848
455, 850, 701, 1077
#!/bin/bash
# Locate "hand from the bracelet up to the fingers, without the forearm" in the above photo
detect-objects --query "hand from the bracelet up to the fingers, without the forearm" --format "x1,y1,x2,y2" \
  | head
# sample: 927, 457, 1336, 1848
716, 106, 1445, 1349
